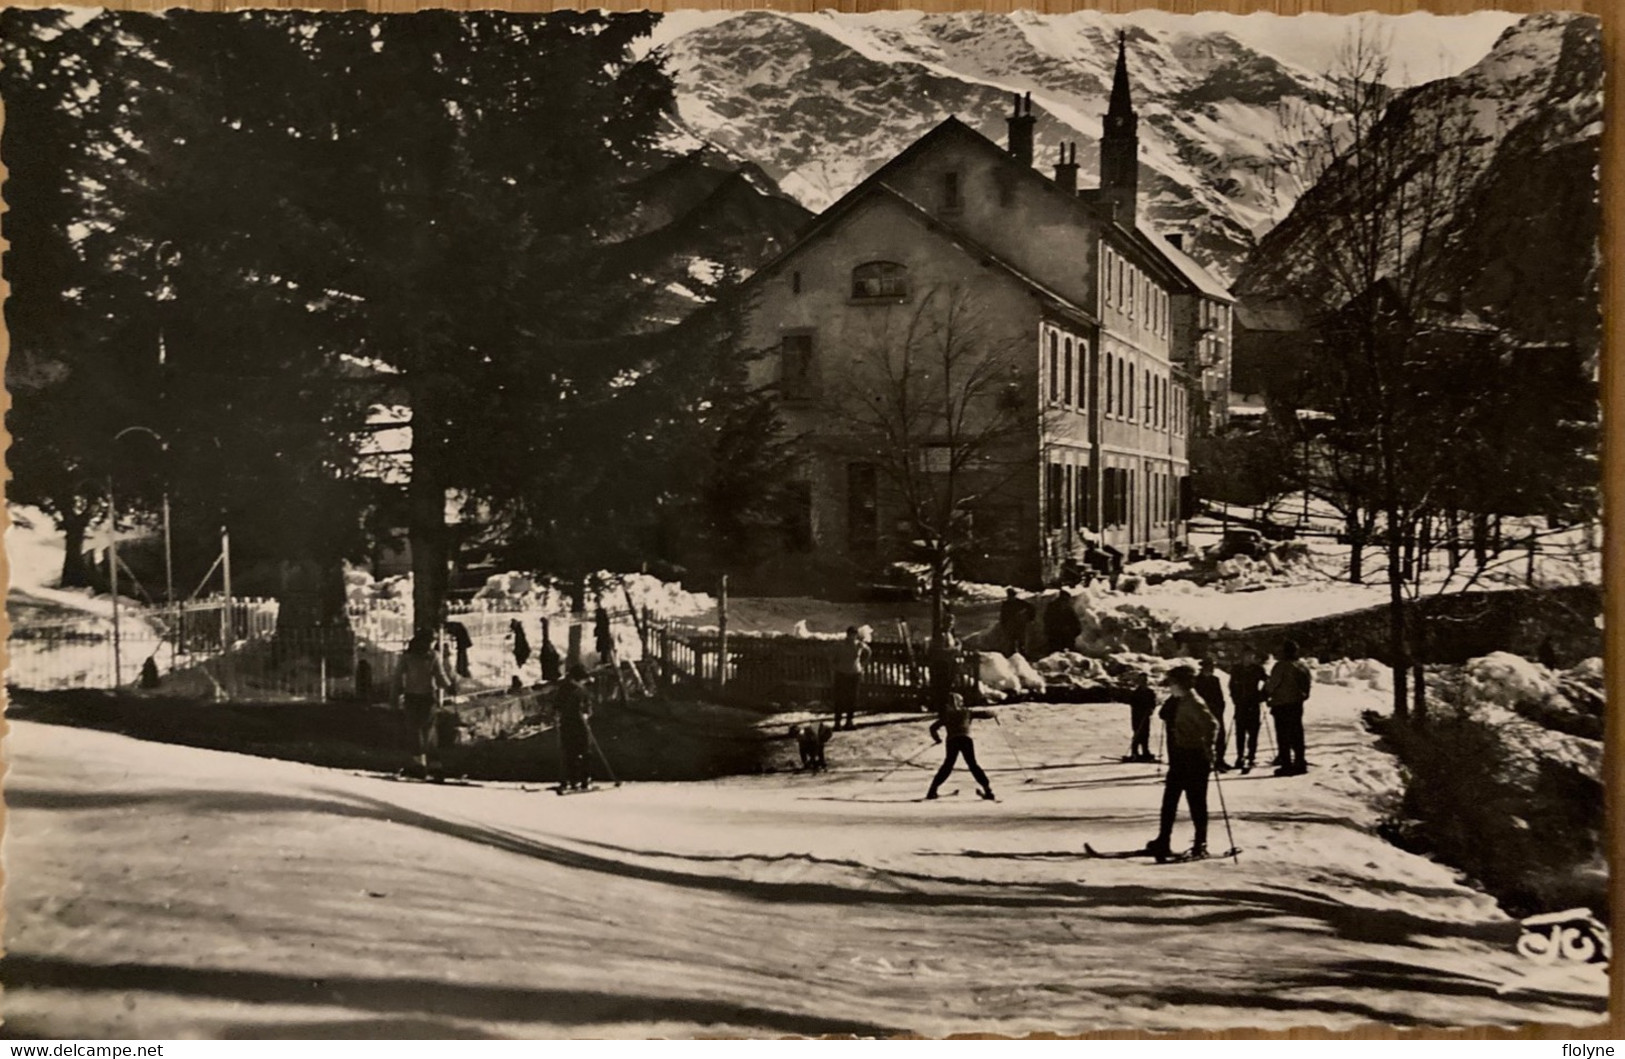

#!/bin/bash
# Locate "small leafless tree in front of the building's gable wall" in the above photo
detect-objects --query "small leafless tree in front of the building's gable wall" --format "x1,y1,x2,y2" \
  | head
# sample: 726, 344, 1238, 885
826, 286, 1045, 637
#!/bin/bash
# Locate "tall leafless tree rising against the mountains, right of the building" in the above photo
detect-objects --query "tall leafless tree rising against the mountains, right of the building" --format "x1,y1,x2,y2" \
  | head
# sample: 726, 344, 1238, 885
1255, 24, 1495, 715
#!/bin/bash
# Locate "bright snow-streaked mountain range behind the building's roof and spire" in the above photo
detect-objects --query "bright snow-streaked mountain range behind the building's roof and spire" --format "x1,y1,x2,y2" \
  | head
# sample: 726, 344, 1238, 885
663, 11, 1321, 282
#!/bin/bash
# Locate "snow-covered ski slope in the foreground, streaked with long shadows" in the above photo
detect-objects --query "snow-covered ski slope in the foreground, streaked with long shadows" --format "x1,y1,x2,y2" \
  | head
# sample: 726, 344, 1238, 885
5, 685, 1607, 1036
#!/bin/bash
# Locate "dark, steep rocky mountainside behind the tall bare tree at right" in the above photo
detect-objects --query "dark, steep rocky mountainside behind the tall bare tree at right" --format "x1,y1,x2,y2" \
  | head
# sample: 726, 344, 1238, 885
1237, 11, 1604, 346
